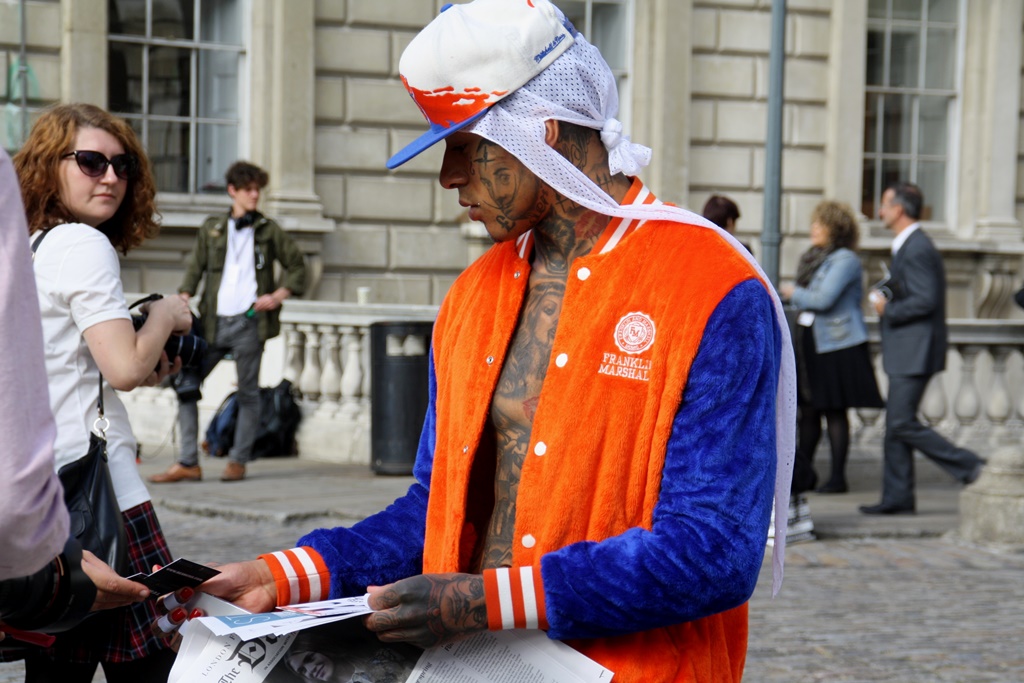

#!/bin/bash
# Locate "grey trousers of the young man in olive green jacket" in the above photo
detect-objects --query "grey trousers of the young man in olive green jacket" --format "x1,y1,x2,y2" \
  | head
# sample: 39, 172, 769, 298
178, 315, 263, 467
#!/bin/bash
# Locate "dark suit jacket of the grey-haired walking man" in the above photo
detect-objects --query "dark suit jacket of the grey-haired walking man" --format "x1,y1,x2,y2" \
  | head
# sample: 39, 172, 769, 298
882, 228, 946, 376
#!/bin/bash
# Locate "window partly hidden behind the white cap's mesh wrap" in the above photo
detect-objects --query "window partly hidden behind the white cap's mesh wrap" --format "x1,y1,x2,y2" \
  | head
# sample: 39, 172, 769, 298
557, 0, 633, 132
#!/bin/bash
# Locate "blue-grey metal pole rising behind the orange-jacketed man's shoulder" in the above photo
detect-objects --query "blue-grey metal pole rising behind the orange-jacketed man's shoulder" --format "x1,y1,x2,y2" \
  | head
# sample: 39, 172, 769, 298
761, 0, 785, 286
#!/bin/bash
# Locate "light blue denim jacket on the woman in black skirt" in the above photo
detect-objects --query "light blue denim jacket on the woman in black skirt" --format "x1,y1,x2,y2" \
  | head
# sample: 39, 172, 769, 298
790, 249, 867, 353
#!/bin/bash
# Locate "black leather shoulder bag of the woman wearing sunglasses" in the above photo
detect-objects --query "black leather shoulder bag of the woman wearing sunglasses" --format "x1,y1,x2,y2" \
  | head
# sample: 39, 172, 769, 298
32, 230, 128, 575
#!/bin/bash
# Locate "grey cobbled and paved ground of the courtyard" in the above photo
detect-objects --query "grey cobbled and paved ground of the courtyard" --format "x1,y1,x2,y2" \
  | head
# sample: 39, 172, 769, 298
0, 450, 1024, 683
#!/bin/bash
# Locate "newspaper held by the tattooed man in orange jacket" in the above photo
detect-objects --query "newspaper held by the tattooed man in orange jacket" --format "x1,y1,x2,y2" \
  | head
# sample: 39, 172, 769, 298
168, 598, 612, 683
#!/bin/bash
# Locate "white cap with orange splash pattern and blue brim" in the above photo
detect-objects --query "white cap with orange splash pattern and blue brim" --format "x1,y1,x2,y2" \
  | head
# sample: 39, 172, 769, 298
387, 0, 577, 168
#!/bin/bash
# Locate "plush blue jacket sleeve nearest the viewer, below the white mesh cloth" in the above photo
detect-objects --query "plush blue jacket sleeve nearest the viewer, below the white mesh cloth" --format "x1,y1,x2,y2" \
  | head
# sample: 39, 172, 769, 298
541, 281, 781, 639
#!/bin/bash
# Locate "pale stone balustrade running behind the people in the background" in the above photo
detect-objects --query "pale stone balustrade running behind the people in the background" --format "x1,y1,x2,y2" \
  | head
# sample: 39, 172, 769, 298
124, 300, 1024, 465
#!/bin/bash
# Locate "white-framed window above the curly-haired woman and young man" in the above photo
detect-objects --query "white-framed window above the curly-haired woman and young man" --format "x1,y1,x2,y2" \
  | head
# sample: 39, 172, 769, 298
109, 0, 245, 193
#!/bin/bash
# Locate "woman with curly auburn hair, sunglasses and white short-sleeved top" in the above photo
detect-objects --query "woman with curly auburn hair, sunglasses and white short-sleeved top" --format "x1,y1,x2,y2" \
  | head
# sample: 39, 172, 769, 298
13, 104, 191, 683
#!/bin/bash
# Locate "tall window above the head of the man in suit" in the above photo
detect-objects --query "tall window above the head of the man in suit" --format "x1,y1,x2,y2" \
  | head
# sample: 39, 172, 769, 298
861, 0, 961, 222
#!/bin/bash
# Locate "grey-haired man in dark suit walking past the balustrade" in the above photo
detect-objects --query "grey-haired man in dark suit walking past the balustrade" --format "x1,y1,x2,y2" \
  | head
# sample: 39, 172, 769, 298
860, 182, 984, 515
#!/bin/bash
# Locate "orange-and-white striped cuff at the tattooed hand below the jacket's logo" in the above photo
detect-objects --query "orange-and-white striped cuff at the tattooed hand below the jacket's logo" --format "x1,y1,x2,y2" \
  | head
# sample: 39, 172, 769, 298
483, 566, 548, 631
